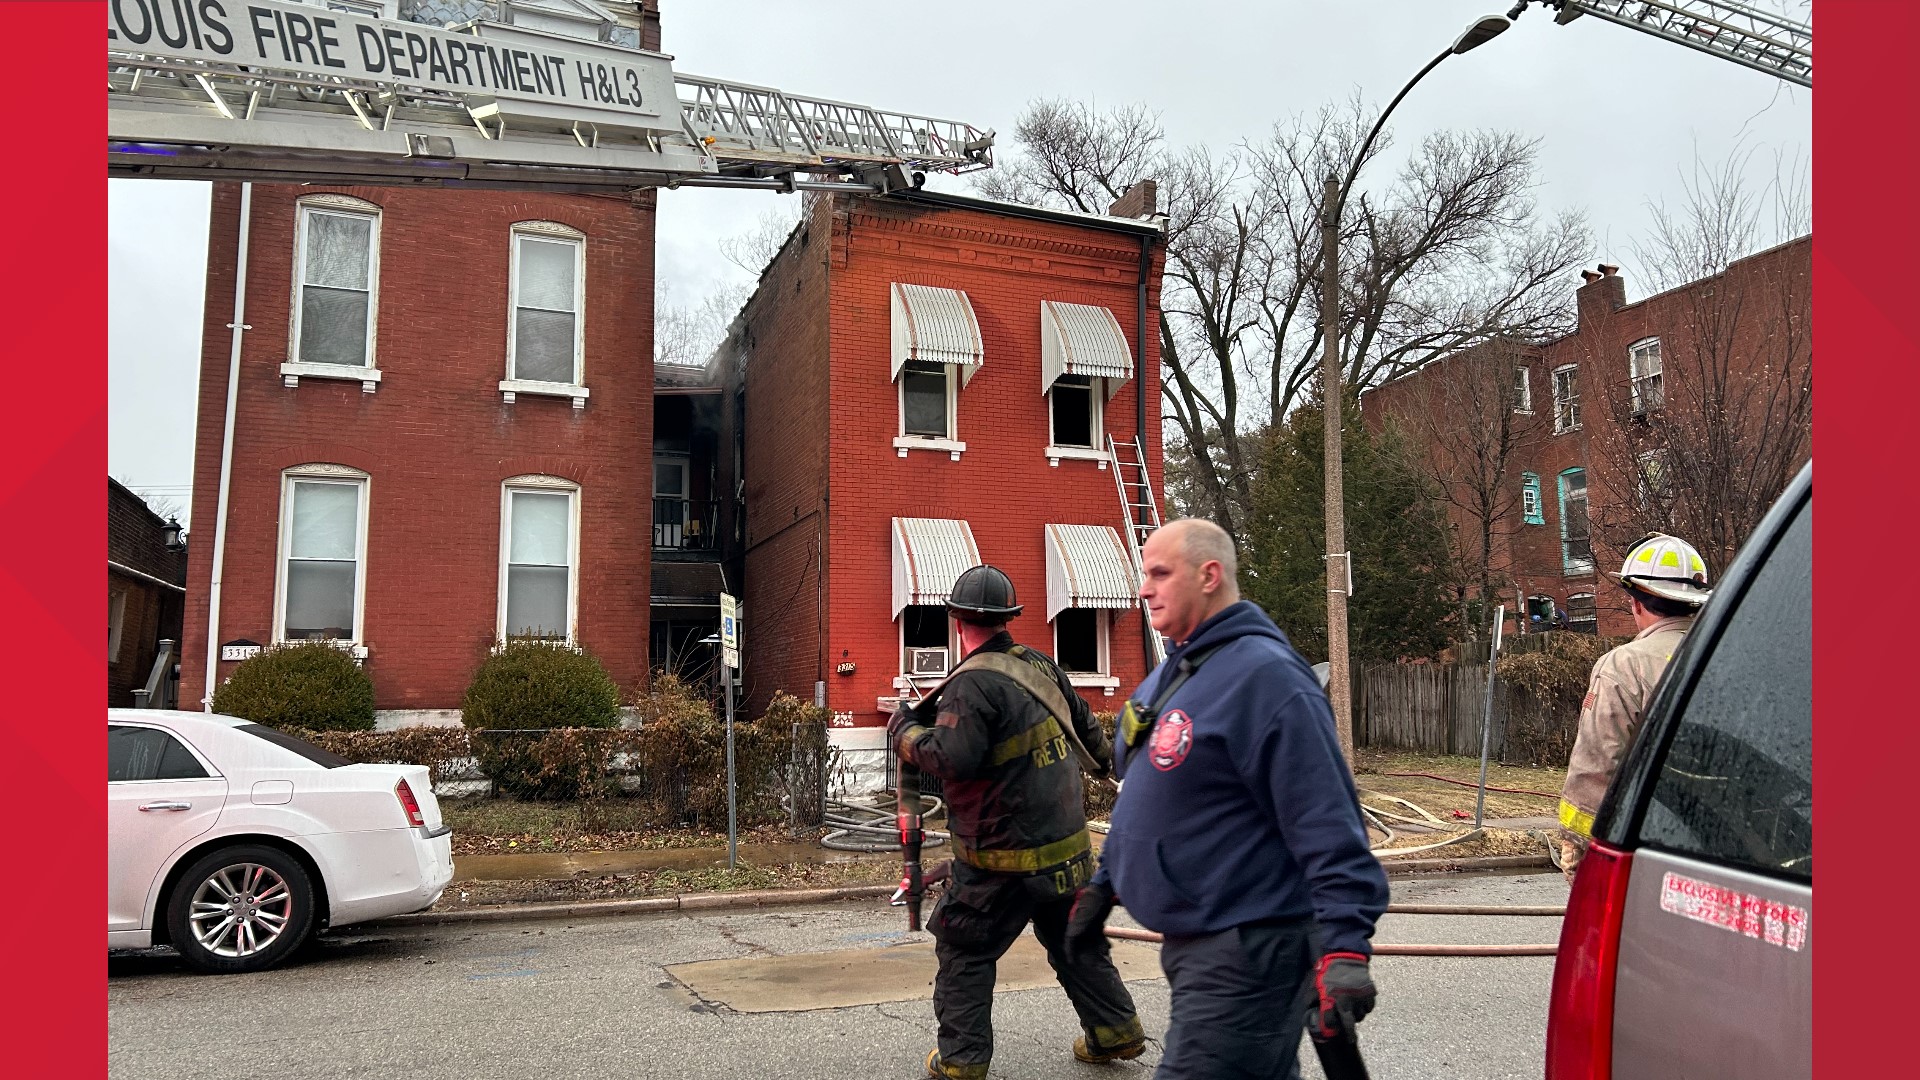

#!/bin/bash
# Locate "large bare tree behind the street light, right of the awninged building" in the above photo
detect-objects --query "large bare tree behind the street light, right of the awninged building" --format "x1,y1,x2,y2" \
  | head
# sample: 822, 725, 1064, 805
979, 100, 1590, 532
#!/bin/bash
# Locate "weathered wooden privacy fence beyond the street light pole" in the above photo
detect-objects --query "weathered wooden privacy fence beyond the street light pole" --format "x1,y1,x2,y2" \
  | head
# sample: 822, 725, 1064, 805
1354, 661, 1580, 765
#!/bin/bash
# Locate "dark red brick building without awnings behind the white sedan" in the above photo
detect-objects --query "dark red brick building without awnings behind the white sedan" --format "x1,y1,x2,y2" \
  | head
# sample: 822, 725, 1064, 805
180, 0, 659, 726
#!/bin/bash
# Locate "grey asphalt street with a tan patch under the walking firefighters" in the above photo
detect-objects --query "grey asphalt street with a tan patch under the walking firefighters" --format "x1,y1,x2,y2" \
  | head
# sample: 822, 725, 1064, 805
108, 872, 1567, 1080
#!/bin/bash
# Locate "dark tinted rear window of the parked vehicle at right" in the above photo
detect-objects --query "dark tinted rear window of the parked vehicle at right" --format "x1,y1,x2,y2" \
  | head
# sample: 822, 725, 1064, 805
1640, 502, 1812, 880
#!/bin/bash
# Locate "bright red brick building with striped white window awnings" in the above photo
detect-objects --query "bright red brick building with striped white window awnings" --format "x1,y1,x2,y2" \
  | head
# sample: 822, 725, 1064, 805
722, 190, 1162, 764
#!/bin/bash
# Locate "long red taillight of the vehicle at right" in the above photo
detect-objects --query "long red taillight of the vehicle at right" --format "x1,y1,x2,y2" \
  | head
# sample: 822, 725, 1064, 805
1546, 844, 1634, 1080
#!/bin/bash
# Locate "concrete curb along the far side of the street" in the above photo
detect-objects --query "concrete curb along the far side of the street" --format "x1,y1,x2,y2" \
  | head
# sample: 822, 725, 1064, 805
357, 855, 1553, 928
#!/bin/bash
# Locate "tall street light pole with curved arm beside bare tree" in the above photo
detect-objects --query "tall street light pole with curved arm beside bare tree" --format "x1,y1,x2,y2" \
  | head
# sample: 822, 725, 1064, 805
1321, 15, 1513, 767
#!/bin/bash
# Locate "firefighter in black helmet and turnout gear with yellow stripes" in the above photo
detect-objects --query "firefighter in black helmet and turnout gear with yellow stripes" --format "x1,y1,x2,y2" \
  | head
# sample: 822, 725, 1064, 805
887, 565, 1146, 1080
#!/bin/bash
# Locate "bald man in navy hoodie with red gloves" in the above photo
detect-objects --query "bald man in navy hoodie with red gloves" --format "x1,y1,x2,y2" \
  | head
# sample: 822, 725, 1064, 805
1068, 519, 1386, 1080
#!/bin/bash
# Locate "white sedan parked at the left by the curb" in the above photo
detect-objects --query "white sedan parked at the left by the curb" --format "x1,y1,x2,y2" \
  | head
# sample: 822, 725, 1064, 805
108, 709, 453, 972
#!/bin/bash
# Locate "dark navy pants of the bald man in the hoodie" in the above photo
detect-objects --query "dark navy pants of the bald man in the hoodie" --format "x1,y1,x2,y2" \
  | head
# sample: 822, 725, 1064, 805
1154, 919, 1319, 1080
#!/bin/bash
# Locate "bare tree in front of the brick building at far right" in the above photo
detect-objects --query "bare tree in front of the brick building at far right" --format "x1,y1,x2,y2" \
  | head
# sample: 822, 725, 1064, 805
1592, 154, 1812, 571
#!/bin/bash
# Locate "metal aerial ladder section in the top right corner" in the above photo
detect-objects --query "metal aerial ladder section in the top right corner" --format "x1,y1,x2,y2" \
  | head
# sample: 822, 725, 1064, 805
1507, 0, 1812, 90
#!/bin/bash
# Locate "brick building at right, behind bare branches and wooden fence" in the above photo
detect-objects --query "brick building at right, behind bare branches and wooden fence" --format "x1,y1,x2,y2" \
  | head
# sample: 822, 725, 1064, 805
1361, 236, 1812, 634
